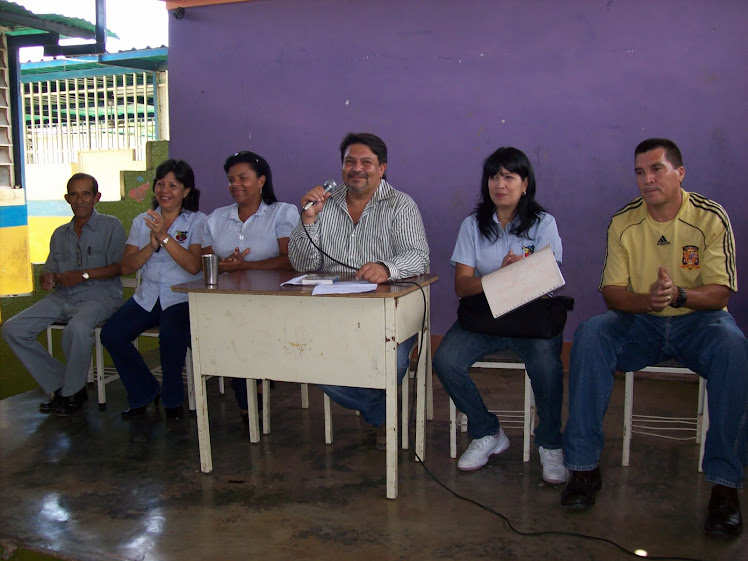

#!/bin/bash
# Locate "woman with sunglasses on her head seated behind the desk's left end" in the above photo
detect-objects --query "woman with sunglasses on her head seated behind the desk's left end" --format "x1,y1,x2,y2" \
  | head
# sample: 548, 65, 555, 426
203, 152, 299, 424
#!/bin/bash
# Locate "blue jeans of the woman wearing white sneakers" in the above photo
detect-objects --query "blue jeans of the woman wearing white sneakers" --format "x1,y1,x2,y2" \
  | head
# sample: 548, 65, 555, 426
434, 322, 564, 450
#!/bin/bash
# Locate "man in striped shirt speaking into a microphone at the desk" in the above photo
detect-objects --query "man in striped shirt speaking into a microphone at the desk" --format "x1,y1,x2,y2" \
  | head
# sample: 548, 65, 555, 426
288, 133, 429, 449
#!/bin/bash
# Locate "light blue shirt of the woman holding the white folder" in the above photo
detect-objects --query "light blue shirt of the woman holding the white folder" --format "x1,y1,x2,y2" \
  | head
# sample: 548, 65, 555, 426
451, 212, 563, 277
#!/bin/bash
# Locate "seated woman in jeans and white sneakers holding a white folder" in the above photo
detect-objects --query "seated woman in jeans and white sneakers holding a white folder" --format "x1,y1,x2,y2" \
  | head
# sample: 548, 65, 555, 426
434, 147, 567, 483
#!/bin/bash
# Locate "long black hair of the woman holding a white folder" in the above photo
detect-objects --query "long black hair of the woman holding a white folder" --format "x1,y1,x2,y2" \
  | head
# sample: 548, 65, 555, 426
474, 146, 545, 242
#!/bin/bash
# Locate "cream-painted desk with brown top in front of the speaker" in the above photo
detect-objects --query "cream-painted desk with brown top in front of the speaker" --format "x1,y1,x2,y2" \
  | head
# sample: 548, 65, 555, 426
172, 271, 439, 499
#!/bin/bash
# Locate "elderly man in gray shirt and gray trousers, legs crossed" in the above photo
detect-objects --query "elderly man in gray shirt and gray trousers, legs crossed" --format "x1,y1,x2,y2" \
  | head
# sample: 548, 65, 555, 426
2, 173, 125, 416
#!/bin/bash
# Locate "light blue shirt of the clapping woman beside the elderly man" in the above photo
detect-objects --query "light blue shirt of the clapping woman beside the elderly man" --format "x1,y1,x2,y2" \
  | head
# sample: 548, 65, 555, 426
127, 207, 206, 311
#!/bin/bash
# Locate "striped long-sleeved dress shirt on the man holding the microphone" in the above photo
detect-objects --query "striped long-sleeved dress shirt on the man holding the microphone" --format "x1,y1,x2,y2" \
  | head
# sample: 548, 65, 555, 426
288, 179, 429, 280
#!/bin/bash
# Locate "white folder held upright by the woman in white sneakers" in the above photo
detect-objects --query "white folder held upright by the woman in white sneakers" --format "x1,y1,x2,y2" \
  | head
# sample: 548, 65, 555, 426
481, 245, 566, 318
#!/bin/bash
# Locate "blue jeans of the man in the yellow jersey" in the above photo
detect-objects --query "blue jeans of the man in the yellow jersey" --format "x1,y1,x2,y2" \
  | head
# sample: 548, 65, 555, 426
564, 311, 748, 488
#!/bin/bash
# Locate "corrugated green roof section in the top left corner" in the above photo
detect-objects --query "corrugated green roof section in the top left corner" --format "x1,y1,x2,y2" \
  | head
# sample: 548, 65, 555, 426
0, 0, 119, 39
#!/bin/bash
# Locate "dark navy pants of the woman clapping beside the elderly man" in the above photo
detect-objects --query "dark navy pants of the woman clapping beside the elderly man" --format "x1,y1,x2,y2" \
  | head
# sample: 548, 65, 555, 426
101, 298, 190, 407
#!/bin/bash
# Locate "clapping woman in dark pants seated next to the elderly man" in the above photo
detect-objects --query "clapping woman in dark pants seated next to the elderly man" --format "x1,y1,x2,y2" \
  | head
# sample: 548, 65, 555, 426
101, 160, 205, 418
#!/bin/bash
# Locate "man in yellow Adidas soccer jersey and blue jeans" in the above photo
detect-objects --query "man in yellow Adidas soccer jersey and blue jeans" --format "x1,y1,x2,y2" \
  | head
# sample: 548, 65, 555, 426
561, 138, 748, 537
